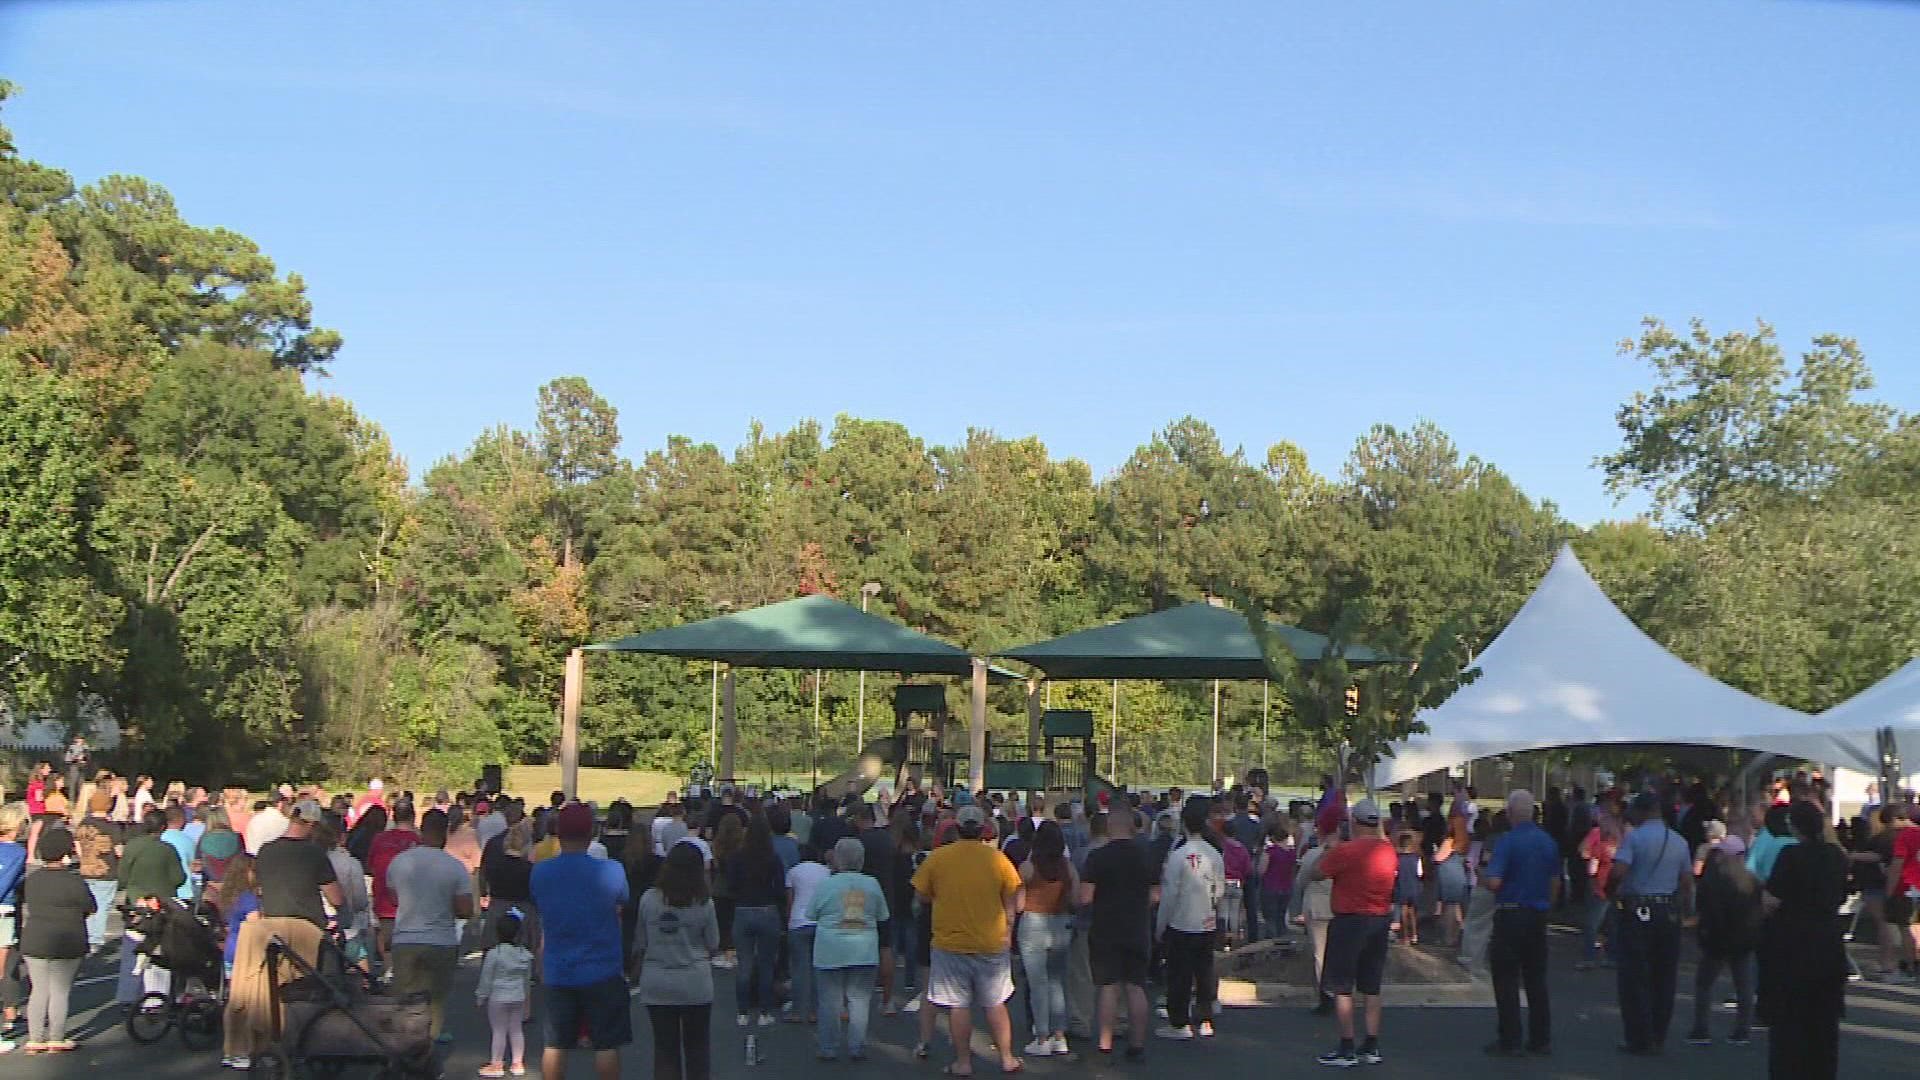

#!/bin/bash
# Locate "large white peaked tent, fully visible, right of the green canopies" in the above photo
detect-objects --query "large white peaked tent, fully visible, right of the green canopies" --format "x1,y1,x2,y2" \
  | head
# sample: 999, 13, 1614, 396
1375, 548, 1876, 786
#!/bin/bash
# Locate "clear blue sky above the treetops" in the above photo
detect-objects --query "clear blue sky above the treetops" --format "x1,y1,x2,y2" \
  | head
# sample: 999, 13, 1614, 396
0, 0, 1920, 521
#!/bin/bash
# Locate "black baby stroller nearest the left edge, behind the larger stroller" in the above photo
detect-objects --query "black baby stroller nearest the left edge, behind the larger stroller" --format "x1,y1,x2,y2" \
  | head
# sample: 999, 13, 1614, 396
127, 901, 223, 1049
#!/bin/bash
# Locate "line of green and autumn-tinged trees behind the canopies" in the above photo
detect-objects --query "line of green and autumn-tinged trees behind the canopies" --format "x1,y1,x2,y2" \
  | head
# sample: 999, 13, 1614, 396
0, 88, 1920, 784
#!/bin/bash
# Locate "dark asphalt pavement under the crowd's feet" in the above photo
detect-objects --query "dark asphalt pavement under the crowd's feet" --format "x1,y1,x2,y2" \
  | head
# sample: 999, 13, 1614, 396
0, 922, 1920, 1080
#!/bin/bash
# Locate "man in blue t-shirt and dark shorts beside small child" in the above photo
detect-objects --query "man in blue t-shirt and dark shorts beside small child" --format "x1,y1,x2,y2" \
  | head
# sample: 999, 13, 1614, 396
532, 803, 634, 1080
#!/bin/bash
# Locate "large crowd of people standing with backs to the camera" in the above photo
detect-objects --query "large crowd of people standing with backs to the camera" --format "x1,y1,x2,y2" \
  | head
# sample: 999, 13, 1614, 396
0, 763, 1920, 1080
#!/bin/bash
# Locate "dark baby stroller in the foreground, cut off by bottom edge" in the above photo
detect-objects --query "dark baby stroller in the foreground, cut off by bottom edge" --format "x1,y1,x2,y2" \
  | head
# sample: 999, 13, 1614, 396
252, 936, 440, 1080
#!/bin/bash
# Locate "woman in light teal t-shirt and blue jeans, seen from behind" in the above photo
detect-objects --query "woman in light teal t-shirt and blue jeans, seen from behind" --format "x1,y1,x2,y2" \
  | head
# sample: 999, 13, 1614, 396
806, 836, 887, 1061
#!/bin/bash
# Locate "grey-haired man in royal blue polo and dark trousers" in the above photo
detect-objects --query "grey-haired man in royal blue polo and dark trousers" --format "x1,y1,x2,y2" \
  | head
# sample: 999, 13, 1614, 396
1482, 788, 1565, 1057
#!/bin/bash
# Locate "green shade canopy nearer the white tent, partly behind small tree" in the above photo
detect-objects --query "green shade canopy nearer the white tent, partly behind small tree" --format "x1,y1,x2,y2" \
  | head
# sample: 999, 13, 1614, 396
1000, 603, 1394, 678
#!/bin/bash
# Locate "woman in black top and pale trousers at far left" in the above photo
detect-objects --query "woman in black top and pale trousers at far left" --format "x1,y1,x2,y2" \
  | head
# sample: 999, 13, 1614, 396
19, 826, 94, 1053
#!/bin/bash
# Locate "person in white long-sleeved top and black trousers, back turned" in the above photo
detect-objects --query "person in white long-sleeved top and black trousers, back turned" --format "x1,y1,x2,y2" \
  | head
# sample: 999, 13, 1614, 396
1154, 796, 1227, 1040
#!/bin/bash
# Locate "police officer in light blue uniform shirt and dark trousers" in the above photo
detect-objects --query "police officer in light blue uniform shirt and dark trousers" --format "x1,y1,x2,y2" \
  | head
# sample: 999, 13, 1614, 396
1609, 780, 1693, 1055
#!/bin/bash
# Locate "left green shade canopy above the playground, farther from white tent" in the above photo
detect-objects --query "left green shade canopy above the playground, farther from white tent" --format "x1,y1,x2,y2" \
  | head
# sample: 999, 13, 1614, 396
588, 596, 1010, 678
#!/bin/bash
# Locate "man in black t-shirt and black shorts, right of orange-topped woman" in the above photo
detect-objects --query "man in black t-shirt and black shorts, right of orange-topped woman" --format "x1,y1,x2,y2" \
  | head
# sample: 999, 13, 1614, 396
1079, 807, 1160, 1061
